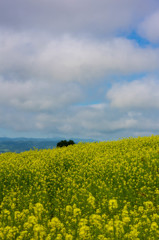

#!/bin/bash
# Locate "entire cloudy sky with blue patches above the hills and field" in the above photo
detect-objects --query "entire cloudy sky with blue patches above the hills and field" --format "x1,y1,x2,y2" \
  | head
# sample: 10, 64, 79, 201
0, 0, 159, 141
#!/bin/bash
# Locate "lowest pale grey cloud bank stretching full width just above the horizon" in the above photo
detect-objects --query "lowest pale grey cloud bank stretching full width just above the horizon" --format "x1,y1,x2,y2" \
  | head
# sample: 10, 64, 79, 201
0, 89, 159, 140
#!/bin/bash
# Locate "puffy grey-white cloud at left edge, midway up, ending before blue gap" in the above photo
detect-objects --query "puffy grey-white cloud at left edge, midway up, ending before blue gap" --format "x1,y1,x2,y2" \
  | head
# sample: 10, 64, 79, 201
0, 79, 83, 113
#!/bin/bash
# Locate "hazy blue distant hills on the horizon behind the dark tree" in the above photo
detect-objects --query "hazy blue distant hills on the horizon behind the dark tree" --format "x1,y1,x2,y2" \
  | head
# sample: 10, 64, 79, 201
0, 137, 94, 153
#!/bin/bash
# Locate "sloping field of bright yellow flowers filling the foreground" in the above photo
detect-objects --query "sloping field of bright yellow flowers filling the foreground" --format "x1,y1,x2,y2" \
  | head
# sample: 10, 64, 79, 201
0, 136, 159, 240
